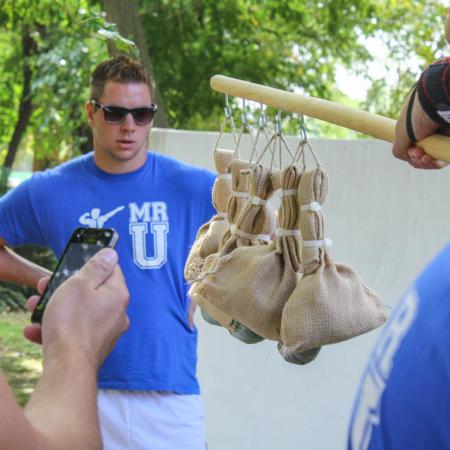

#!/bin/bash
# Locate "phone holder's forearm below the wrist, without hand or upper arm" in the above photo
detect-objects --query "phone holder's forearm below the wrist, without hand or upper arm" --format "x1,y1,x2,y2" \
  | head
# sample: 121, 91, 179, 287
24, 350, 102, 450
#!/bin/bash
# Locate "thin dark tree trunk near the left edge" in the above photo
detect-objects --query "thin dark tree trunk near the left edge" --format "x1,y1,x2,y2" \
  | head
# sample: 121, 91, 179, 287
0, 30, 37, 193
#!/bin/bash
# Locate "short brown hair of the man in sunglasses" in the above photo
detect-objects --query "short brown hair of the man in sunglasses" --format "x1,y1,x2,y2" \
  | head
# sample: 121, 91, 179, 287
90, 54, 153, 101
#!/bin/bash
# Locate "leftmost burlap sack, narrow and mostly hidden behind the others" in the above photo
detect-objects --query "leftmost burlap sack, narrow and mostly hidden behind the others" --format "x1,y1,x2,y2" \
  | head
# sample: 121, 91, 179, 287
184, 149, 234, 283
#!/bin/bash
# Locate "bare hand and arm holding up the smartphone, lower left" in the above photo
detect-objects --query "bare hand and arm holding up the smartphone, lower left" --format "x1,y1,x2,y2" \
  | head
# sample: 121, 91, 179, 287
0, 249, 128, 450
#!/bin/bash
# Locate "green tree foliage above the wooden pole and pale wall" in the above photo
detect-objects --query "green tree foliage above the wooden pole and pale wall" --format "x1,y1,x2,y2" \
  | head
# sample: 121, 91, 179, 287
141, 0, 445, 133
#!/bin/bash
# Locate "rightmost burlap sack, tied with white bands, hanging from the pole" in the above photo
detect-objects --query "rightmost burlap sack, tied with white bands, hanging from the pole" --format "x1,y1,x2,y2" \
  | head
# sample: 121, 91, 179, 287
279, 168, 386, 356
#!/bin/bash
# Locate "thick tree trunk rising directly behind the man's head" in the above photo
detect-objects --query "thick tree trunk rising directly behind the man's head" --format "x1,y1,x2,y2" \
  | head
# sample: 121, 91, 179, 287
104, 0, 169, 128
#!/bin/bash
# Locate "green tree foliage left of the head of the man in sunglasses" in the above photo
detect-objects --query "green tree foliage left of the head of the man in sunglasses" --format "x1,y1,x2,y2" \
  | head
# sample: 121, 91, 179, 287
0, 0, 134, 178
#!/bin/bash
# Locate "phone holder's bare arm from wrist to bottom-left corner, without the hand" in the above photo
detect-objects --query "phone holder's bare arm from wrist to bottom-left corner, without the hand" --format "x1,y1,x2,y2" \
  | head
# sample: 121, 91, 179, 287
0, 355, 101, 450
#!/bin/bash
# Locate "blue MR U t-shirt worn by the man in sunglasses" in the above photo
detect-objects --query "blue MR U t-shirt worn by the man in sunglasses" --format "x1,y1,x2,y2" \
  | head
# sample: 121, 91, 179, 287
0, 152, 215, 394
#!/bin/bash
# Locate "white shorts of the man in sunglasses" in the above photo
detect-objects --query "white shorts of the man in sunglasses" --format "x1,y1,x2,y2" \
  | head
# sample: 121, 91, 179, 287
97, 389, 206, 450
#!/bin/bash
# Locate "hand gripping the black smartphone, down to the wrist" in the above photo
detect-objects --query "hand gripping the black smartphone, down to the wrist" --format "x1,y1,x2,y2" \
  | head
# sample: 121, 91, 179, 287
24, 249, 129, 370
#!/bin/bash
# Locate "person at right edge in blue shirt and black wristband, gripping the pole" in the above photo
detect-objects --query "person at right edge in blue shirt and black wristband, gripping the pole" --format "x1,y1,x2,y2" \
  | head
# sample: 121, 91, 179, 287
348, 9, 450, 450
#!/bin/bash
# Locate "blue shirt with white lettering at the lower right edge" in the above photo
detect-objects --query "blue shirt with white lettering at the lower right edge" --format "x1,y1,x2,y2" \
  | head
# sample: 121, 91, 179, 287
348, 244, 450, 450
